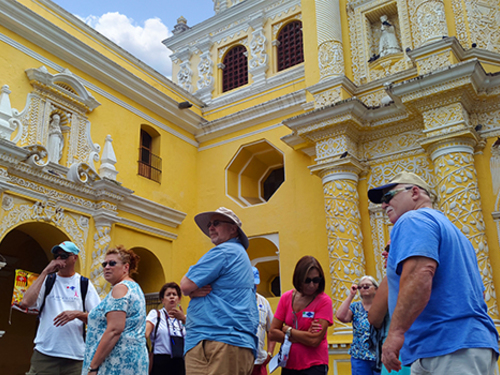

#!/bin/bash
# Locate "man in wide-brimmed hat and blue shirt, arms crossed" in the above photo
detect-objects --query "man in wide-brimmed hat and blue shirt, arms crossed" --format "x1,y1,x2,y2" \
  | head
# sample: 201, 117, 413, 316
181, 207, 259, 375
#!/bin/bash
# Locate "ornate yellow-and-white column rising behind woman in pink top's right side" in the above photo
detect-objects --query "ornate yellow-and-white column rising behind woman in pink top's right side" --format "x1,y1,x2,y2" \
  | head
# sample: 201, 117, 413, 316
311, 157, 365, 334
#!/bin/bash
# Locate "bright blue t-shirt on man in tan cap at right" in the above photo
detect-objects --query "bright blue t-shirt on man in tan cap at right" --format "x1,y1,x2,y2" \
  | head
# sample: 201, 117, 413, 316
387, 208, 498, 365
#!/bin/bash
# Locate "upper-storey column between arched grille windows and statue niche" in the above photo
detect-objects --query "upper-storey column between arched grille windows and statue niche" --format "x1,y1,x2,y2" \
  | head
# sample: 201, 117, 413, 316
315, 0, 344, 81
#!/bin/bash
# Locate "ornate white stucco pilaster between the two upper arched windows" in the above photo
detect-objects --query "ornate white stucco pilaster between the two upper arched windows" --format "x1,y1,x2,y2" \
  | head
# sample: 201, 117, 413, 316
248, 12, 269, 88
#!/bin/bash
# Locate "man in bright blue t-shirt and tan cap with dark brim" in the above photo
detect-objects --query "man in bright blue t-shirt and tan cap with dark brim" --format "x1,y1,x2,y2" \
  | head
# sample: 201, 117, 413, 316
368, 172, 498, 375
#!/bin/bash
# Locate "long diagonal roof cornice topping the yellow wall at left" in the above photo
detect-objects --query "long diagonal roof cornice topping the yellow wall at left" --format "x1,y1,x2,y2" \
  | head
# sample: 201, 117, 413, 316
0, 0, 204, 133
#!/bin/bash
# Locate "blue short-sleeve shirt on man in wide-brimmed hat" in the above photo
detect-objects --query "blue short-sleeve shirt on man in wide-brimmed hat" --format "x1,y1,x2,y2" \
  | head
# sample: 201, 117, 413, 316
185, 238, 259, 355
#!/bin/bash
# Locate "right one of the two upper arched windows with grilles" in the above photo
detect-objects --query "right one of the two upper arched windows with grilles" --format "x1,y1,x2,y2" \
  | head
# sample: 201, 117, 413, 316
278, 21, 304, 71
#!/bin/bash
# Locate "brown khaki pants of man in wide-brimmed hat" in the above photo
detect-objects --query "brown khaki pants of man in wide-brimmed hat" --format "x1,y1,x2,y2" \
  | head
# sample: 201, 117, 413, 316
185, 340, 255, 375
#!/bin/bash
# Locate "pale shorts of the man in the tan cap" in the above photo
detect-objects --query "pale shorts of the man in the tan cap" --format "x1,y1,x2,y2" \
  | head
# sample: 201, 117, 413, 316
411, 348, 498, 375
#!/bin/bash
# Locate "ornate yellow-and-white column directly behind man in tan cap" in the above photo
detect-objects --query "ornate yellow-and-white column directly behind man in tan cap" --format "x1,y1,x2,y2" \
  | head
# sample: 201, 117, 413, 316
421, 102, 500, 326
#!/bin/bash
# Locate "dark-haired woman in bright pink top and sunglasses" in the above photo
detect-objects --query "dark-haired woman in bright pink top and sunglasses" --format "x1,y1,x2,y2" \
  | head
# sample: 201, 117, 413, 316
270, 256, 333, 375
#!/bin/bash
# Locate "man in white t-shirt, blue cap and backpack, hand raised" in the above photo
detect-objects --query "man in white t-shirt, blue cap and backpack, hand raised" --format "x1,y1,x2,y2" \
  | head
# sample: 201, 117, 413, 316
21, 241, 100, 375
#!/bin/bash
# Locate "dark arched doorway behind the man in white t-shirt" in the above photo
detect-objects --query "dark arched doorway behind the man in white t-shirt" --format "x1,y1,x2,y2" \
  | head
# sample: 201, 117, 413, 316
0, 222, 72, 375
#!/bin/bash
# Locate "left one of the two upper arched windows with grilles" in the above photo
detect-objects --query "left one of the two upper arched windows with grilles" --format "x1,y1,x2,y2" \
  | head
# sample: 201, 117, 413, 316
222, 45, 248, 92
